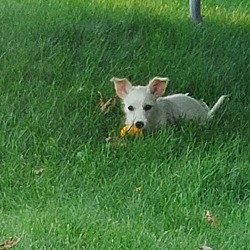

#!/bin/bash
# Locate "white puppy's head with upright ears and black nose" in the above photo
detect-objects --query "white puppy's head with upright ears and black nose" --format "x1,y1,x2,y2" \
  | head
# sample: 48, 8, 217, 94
111, 77, 168, 129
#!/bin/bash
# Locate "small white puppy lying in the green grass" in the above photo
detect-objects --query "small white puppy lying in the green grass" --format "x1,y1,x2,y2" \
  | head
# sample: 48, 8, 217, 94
111, 77, 227, 129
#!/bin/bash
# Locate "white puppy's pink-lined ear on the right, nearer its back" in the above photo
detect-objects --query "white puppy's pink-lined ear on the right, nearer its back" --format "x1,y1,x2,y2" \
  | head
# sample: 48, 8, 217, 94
148, 77, 169, 97
